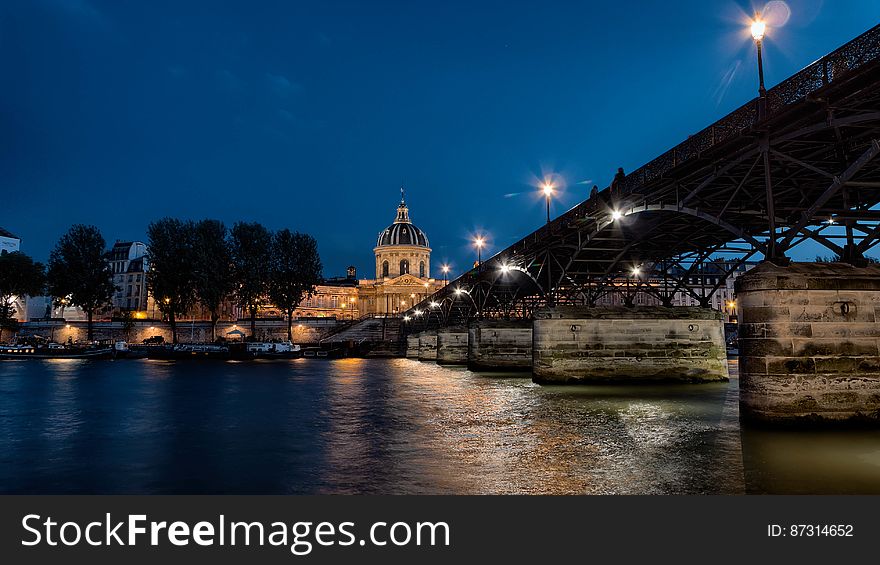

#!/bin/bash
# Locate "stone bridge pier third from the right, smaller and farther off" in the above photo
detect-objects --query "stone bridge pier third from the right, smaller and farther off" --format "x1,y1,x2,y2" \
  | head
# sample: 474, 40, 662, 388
467, 320, 532, 372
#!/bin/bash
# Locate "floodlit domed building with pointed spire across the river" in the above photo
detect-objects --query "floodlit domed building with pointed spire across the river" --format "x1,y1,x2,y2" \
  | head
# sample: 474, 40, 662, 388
358, 193, 443, 315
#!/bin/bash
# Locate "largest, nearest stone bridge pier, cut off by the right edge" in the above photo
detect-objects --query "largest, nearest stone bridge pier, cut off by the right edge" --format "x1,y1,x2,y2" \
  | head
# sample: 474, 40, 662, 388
736, 263, 880, 423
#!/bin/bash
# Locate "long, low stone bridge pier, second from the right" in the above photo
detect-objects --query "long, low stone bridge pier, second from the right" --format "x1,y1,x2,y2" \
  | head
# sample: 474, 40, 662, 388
532, 306, 728, 384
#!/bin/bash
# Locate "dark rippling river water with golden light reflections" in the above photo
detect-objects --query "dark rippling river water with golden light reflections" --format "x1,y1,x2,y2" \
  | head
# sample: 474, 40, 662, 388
0, 359, 880, 494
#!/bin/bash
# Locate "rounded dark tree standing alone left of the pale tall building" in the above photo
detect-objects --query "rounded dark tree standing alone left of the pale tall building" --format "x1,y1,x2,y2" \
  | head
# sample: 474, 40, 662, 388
48, 224, 116, 340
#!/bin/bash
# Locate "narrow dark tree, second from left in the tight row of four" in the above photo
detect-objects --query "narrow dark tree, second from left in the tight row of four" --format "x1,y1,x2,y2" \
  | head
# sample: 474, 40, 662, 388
194, 220, 234, 341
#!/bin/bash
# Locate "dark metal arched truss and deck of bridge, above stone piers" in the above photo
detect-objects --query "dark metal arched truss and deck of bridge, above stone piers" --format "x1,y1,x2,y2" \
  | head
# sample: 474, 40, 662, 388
405, 26, 880, 331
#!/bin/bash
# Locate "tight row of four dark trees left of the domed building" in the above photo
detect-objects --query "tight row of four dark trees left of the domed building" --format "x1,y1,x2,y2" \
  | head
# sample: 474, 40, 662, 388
147, 218, 322, 342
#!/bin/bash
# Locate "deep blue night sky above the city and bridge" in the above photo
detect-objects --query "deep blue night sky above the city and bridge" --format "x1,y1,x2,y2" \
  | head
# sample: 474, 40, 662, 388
0, 0, 880, 277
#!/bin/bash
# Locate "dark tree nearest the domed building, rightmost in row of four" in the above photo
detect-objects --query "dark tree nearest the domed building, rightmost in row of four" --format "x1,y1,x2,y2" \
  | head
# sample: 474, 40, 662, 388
269, 229, 322, 341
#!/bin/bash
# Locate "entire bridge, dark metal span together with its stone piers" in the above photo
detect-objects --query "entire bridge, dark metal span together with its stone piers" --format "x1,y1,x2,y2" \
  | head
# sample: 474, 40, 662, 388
404, 26, 880, 426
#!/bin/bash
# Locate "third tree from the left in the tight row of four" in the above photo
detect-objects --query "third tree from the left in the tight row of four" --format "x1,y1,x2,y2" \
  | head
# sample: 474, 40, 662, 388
230, 222, 272, 338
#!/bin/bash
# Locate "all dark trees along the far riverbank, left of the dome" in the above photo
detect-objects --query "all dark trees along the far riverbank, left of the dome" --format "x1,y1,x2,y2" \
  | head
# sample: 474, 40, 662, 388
0, 218, 322, 343
